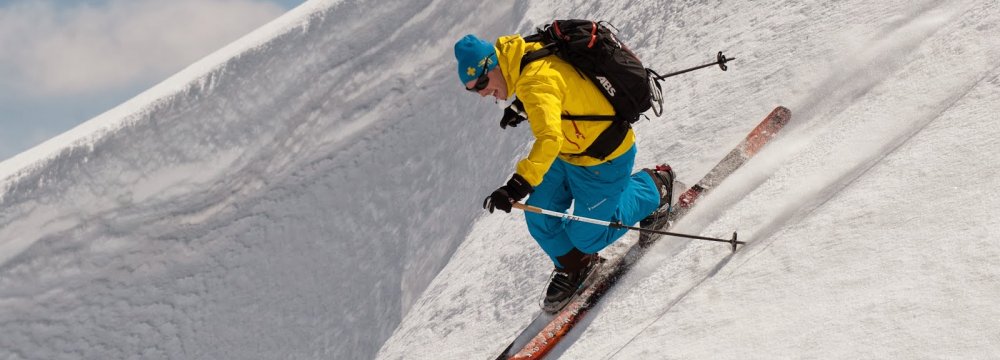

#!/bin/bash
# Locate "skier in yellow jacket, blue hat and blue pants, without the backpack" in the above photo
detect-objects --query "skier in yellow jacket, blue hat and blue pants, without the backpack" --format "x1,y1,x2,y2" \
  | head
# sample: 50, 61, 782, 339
455, 35, 674, 313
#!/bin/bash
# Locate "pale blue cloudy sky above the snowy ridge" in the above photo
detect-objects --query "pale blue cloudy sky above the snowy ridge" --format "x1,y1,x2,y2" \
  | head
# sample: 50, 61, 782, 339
0, 0, 304, 161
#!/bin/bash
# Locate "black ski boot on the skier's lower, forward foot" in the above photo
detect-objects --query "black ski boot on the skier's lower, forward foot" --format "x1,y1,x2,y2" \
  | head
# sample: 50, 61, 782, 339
542, 248, 603, 314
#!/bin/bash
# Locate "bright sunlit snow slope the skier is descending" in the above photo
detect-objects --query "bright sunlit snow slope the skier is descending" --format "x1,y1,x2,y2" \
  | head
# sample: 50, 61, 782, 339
380, 1, 1000, 359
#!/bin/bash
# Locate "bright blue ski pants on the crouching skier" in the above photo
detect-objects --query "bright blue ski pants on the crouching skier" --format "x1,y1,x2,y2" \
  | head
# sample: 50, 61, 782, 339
524, 146, 660, 267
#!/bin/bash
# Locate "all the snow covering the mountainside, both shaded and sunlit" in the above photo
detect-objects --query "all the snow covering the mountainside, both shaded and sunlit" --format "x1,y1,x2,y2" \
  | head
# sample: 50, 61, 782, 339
0, 0, 1000, 359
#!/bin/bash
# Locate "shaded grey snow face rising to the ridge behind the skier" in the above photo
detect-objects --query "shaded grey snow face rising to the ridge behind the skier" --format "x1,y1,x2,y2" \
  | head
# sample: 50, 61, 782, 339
0, 1, 527, 359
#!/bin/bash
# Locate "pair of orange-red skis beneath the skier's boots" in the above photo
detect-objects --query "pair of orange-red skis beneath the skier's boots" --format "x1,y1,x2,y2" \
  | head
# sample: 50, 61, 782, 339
497, 106, 791, 360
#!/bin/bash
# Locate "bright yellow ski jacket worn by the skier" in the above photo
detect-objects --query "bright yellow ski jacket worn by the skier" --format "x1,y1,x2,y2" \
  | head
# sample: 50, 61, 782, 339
495, 35, 635, 186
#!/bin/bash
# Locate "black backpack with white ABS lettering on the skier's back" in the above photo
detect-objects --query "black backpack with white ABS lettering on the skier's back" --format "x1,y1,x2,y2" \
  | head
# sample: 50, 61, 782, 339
508, 20, 663, 160
